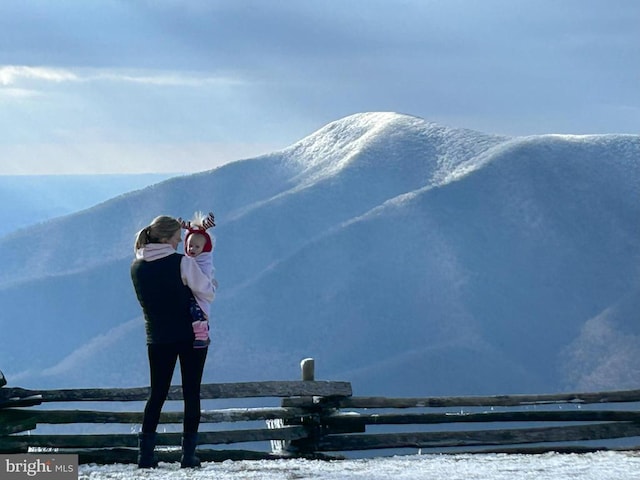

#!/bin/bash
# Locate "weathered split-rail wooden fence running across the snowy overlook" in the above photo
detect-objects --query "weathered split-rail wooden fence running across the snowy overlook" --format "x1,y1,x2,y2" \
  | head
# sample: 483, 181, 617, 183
0, 359, 640, 464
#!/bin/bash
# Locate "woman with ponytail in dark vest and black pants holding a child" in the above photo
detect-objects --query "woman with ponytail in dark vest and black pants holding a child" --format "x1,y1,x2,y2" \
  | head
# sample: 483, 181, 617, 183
131, 216, 214, 468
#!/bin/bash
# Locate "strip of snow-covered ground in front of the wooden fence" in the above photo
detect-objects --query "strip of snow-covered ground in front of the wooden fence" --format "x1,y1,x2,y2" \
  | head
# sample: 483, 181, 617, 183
79, 452, 640, 480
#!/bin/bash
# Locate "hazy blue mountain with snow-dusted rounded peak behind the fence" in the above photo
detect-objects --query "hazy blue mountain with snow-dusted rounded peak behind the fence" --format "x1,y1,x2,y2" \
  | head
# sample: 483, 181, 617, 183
0, 113, 640, 395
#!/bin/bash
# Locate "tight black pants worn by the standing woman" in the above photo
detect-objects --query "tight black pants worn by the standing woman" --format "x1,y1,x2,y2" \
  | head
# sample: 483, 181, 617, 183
142, 342, 208, 433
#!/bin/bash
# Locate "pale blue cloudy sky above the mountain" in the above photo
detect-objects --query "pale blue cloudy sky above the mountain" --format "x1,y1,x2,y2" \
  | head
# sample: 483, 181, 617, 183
0, 0, 640, 175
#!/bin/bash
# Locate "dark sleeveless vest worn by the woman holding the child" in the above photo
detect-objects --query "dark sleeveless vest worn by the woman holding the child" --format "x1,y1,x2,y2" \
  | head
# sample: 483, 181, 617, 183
131, 253, 194, 344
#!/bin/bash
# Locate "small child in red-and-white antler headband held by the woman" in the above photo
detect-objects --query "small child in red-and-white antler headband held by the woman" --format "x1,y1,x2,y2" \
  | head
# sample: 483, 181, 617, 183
182, 212, 218, 348
